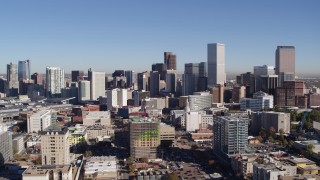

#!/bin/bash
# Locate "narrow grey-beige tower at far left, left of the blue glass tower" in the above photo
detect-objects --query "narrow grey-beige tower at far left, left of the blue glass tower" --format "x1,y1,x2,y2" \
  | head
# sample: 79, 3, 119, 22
7, 63, 19, 96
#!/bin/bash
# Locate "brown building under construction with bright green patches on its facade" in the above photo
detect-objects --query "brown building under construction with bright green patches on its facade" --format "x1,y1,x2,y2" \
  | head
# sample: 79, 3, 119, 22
129, 121, 160, 159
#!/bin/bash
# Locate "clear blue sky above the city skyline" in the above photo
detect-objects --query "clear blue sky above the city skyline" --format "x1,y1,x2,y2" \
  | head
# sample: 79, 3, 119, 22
0, 0, 320, 74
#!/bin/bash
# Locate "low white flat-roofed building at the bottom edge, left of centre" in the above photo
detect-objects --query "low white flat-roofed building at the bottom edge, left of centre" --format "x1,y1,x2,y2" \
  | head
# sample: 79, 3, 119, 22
84, 156, 117, 179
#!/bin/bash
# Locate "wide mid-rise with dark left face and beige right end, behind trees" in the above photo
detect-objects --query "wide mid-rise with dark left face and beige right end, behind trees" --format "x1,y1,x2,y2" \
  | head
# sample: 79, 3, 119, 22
250, 111, 290, 135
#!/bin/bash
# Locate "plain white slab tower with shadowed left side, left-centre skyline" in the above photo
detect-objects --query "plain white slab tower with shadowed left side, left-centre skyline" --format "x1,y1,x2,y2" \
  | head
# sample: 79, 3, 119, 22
88, 69, 106, 100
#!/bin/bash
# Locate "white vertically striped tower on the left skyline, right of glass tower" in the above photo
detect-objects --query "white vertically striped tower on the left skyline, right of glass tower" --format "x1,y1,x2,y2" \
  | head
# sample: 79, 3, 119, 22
46, 67, 65, 96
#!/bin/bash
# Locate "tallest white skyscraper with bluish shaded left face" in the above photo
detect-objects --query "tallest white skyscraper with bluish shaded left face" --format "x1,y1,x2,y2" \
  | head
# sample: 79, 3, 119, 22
208, 43, 226, 87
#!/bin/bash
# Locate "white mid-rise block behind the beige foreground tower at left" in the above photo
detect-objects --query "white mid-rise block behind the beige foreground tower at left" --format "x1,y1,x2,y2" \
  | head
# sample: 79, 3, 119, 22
27, 110, 51, 133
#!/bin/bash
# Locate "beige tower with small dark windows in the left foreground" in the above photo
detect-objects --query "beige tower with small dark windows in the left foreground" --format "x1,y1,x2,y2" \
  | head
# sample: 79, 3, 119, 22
40, 126, 70, 165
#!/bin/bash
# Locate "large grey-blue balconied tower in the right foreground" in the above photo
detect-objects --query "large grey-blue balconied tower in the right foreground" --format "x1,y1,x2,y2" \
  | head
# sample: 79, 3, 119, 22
213, 114, 249, 155
